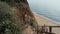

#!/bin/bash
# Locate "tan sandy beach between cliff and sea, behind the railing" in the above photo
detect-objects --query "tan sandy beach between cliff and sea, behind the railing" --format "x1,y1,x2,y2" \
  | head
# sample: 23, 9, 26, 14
34, 13, 60, 34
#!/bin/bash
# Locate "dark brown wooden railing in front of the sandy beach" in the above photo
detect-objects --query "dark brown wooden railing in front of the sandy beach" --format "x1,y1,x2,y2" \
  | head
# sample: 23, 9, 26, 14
36, 25, 60, 34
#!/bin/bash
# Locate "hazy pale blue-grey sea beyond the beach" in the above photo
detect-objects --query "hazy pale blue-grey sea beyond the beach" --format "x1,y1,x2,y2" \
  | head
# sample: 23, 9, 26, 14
28, 0, 60, 23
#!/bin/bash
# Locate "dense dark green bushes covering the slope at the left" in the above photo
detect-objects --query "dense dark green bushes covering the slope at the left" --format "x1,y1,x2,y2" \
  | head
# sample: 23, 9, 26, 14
0, 2, 23, 34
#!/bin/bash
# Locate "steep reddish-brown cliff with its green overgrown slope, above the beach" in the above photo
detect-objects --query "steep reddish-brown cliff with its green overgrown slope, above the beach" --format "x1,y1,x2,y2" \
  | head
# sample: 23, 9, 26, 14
0, 0, 36, 34
